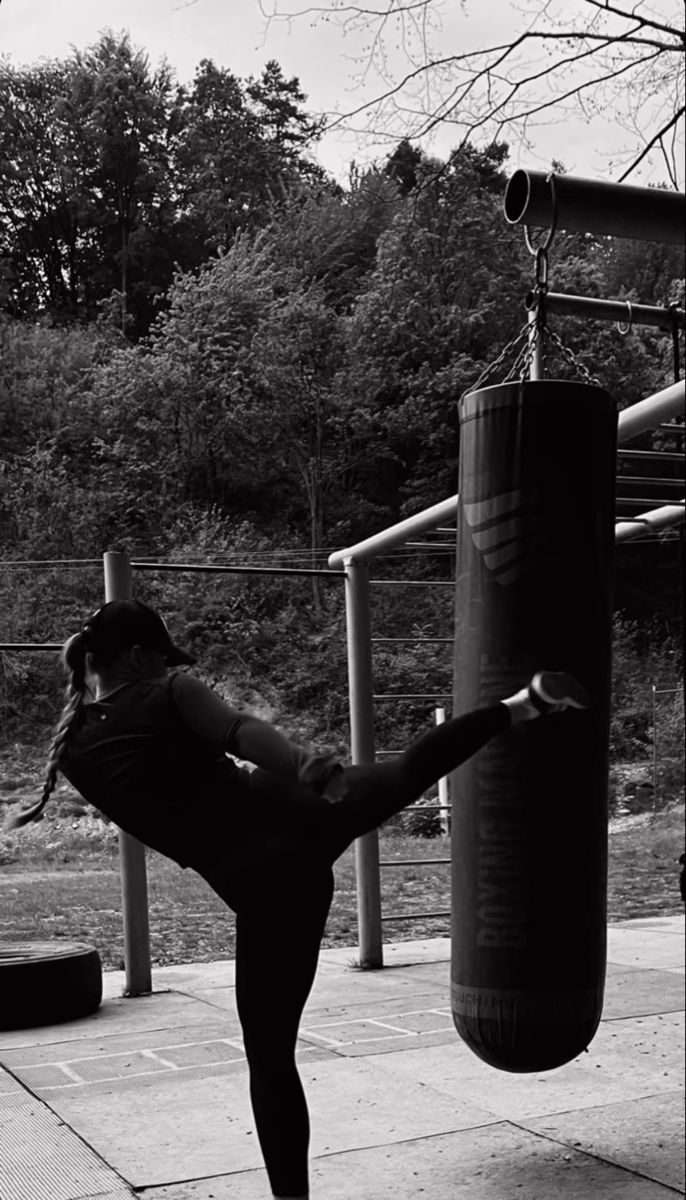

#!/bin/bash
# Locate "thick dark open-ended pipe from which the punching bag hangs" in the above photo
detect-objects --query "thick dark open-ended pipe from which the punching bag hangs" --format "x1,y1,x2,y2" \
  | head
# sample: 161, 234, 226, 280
503, 170, 685, 246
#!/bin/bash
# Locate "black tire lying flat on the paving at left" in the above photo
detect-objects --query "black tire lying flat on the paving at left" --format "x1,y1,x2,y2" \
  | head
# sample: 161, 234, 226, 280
0, 942, 102, 1030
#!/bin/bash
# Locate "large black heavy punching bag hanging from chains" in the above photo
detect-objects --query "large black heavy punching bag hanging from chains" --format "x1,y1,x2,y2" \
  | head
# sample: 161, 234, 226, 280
451, 379, 616, 1072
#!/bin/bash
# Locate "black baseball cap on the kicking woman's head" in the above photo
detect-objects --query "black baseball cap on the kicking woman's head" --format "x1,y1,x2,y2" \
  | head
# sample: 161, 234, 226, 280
82, 600, 197, 667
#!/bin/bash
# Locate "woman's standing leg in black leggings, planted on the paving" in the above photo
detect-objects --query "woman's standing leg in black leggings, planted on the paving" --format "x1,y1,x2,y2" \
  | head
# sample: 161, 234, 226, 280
203, 847, 333, 1198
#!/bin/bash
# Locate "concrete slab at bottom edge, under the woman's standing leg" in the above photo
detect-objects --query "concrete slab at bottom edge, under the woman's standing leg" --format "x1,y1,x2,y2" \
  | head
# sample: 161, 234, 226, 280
140, 1123, 674, 1200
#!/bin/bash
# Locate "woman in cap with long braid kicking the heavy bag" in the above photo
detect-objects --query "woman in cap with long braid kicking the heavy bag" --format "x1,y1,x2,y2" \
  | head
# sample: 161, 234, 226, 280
10, 600, 588, 1200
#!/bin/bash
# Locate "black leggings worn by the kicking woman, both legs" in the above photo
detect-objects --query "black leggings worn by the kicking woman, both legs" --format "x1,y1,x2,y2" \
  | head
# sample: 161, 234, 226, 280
197, 704, 510, 1196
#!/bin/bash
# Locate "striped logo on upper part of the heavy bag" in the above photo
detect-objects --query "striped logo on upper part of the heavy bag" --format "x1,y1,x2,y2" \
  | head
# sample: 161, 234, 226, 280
462, 488, 544, 586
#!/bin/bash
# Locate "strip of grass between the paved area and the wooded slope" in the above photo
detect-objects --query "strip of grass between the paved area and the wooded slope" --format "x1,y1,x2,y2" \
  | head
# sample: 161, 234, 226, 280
0, 797, 684, 970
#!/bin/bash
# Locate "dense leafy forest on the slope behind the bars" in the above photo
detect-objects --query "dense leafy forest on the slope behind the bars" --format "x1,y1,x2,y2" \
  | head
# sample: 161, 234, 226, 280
0, 32, 684, 796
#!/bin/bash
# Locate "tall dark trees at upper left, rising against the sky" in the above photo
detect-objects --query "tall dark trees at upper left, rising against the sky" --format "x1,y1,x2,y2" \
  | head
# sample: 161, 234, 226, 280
0, 34, 184, 335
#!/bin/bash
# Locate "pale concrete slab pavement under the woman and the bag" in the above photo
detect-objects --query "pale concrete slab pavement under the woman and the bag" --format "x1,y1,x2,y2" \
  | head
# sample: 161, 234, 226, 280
0, 917, 685, 1200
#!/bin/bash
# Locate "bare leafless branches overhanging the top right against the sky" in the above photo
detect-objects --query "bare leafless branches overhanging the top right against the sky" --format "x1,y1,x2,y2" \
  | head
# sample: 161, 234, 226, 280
263, 0, 685, 186
